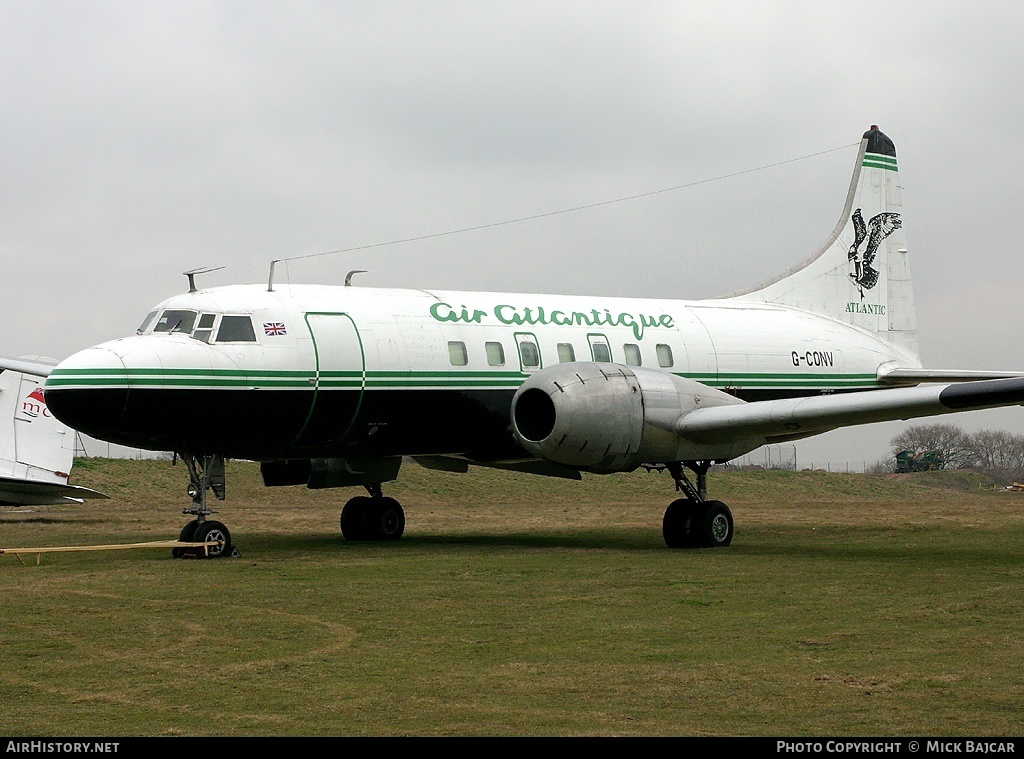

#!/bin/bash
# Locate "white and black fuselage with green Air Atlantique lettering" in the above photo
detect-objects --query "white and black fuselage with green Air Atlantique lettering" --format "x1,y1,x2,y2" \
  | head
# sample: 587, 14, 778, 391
46, 285, 913, 461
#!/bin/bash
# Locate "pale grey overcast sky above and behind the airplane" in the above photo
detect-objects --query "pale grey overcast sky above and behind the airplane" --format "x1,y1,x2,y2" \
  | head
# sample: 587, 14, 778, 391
0, 0, 1024, 467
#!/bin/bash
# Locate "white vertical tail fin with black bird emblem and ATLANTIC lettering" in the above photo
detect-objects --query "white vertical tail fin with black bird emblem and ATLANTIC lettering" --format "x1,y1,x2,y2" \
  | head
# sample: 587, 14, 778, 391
727, 126, 918, 363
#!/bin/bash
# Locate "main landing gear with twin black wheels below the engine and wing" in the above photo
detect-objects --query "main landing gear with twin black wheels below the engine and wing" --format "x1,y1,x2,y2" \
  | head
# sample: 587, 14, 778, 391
662, 461, 732, 548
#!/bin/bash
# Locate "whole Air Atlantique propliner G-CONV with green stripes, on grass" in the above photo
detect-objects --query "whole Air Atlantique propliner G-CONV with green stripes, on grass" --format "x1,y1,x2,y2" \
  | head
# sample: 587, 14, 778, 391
8, 127, 1024, 555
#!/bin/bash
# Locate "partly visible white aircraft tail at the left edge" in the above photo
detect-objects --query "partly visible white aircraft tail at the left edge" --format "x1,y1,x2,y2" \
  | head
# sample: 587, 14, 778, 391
0, 361, 106, 506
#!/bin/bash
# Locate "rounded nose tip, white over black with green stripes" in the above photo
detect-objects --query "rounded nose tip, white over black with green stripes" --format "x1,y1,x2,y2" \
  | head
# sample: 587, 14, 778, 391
43, 346, 128, 437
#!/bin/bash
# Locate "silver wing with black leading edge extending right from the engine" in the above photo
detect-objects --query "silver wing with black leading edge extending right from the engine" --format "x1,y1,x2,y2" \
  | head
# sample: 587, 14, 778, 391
673, 377, 1024, 442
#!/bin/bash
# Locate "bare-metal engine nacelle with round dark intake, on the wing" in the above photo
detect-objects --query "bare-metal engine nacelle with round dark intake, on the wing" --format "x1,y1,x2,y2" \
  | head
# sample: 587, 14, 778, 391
512, 362, 763, 472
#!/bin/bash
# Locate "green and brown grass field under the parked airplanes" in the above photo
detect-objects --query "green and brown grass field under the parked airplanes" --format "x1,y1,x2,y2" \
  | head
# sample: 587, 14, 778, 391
0, 459, 1024, 736
